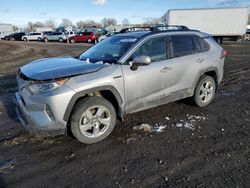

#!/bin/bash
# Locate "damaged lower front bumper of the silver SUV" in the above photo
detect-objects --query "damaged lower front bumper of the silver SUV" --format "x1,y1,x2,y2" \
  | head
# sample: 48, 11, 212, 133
14, 92, 66, 136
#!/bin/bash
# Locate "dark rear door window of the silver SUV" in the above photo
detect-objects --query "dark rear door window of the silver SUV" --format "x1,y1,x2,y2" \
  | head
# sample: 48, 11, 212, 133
171, 35, 195, 57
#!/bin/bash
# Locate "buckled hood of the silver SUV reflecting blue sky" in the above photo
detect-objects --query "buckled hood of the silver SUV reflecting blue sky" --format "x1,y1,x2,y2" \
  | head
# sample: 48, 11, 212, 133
20, 57, 105, 81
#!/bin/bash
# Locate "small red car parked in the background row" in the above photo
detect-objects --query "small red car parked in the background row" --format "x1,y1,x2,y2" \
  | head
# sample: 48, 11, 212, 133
69, 32, 98, 43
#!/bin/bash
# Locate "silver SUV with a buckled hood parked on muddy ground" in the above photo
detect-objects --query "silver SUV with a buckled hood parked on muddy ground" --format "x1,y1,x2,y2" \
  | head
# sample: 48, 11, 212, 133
15, 26, 225, 144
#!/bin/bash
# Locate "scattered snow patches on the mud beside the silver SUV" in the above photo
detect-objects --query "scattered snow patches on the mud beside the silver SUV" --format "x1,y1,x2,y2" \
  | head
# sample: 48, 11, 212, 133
133, 114, 206, 133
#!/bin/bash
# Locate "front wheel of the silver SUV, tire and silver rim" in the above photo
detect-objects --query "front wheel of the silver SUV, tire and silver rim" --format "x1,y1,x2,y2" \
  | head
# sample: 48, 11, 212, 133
70, 97, 116, 144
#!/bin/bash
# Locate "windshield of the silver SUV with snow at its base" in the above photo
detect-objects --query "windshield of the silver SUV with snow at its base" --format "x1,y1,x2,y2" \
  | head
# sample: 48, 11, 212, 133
79, 36, 137, 63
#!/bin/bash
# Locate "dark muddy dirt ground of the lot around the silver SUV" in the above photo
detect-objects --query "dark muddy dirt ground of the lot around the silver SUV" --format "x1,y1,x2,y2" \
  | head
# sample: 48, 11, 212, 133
0, 41, 250, 188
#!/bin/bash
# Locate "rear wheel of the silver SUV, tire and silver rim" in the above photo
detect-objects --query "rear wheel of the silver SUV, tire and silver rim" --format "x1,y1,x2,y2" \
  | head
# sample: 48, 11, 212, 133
193, 75, 216, 107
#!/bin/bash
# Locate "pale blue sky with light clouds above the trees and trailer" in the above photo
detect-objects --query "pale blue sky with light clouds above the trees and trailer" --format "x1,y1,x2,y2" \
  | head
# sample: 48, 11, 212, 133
0, 0, 250, 26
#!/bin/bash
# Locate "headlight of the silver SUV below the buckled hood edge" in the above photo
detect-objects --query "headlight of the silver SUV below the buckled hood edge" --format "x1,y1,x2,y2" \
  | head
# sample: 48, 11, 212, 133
28, 79, 68, 94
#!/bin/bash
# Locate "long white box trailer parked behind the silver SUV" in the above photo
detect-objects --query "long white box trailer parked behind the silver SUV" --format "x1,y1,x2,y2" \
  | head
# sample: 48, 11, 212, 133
166, 7, 249, 40
